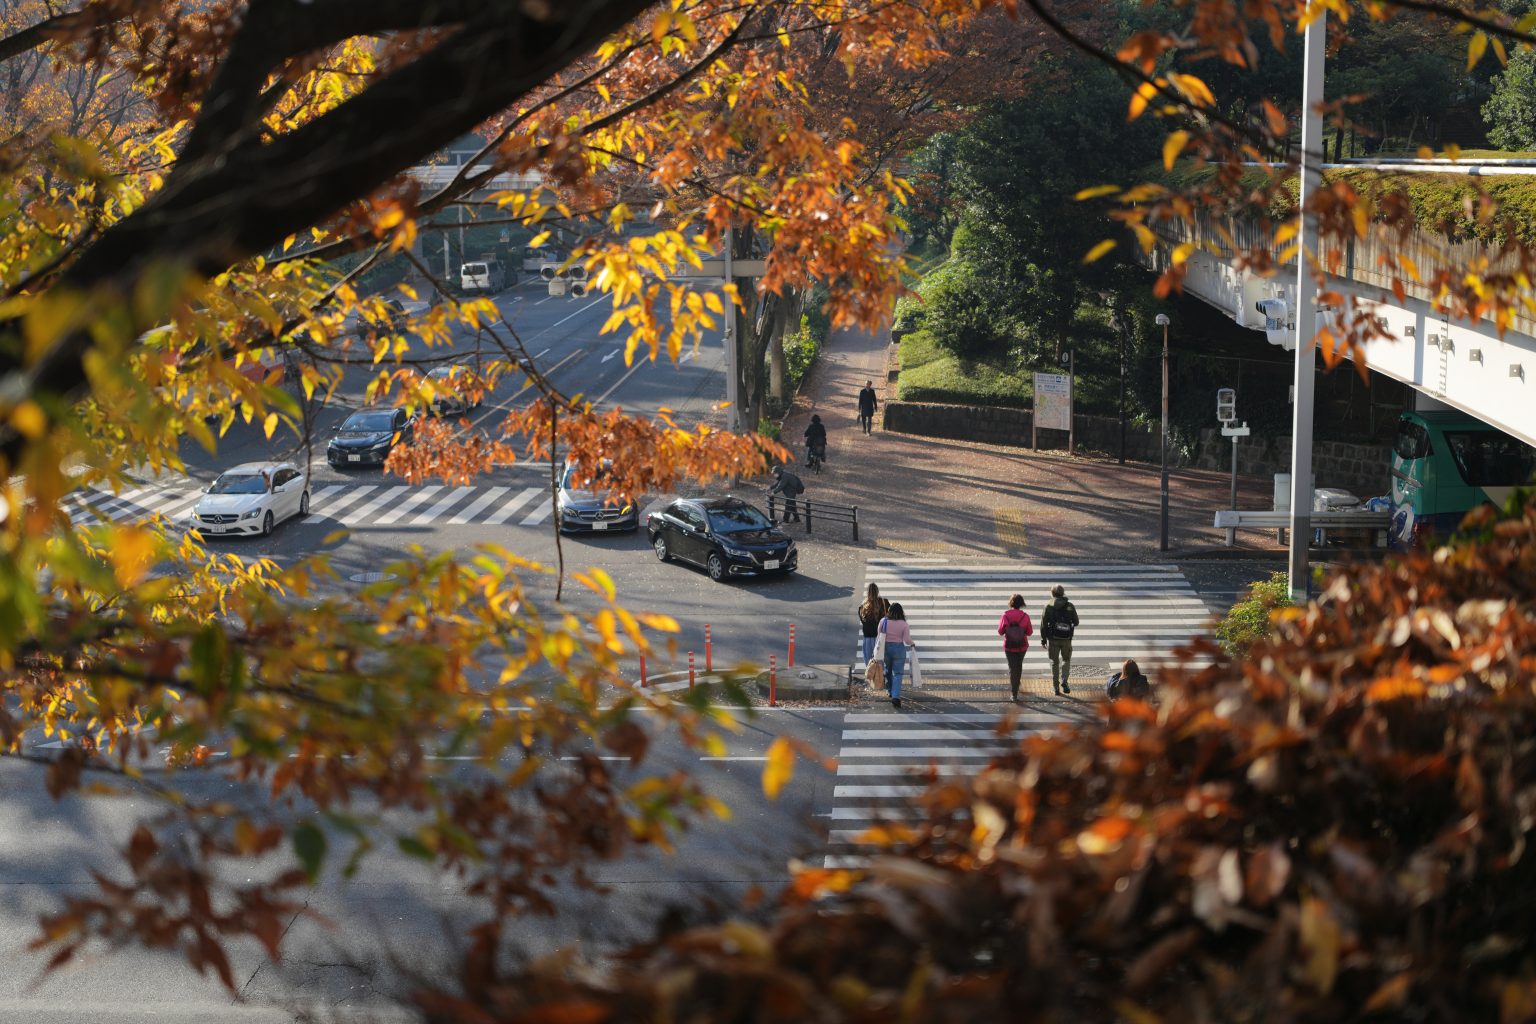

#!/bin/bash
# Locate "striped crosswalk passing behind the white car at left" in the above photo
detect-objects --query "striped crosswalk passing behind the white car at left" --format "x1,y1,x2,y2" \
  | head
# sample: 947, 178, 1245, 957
61, 482, 565, 527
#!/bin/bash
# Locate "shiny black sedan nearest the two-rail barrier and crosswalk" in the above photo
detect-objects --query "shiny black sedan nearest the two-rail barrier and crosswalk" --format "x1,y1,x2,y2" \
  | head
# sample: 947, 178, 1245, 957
645, 497, 800, 580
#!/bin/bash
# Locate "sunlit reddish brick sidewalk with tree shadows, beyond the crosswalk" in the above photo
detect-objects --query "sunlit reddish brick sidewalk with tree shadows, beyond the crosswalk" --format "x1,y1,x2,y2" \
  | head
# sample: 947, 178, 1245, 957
783, 323, 1284, 562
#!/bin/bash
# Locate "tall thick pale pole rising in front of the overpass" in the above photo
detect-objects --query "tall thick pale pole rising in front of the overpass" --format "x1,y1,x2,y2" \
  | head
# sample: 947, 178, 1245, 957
1289, 5, 1329, 603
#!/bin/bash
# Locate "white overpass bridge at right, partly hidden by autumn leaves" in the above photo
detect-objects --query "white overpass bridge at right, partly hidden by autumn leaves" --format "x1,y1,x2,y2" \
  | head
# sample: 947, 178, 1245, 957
1141, 204, 1536, 445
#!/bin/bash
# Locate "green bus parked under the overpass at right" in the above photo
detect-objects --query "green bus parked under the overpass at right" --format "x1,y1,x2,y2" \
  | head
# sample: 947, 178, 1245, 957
1390, 410, 1536, 548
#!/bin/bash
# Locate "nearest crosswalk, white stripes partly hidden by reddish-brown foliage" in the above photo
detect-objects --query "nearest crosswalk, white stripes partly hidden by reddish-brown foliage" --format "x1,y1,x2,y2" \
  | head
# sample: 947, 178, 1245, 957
825, 705, 1063, 867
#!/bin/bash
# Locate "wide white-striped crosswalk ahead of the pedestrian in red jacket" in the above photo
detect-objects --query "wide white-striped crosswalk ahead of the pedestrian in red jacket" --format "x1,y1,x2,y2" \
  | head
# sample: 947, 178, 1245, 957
856, 557, 1210, 679
